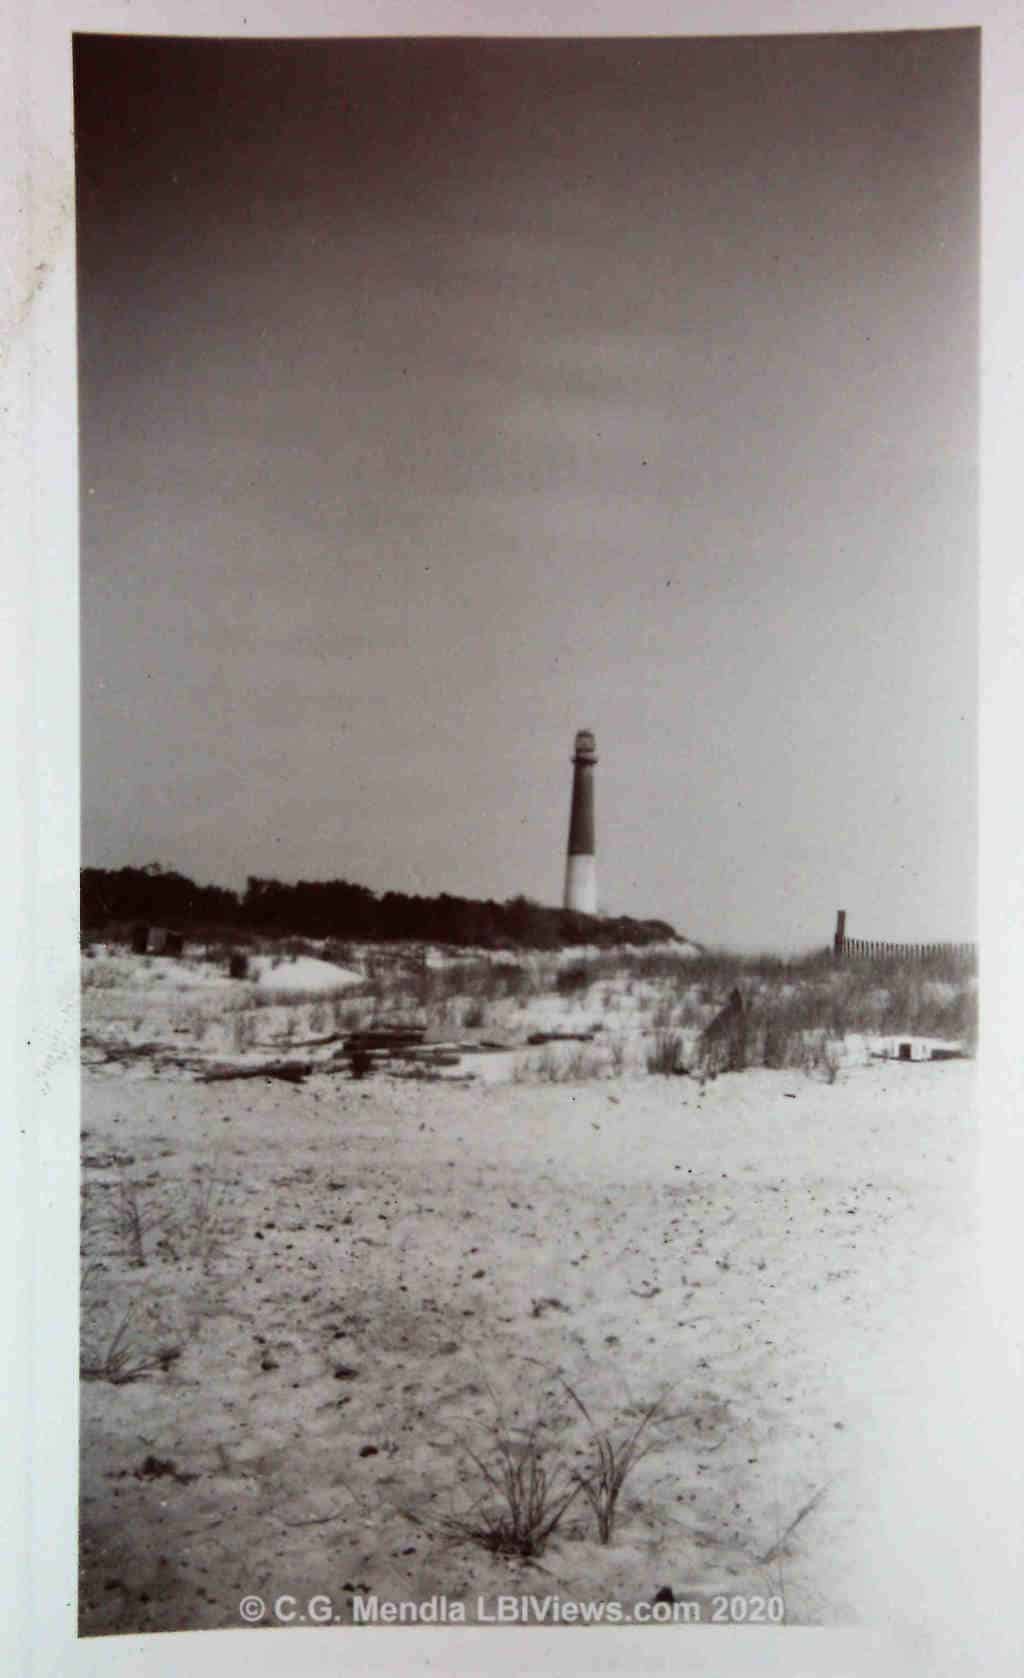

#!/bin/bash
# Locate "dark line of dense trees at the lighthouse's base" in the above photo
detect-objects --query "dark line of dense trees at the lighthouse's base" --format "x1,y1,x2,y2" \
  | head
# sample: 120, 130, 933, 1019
81, 864, 678, 950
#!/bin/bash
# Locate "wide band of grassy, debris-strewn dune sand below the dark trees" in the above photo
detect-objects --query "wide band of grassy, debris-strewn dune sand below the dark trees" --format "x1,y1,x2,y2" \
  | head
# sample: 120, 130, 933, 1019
82, 936, 977, 1087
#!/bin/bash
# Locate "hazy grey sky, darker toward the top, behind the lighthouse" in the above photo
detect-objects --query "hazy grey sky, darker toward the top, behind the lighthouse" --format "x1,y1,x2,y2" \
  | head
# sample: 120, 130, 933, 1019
77, 32, 977, 948
